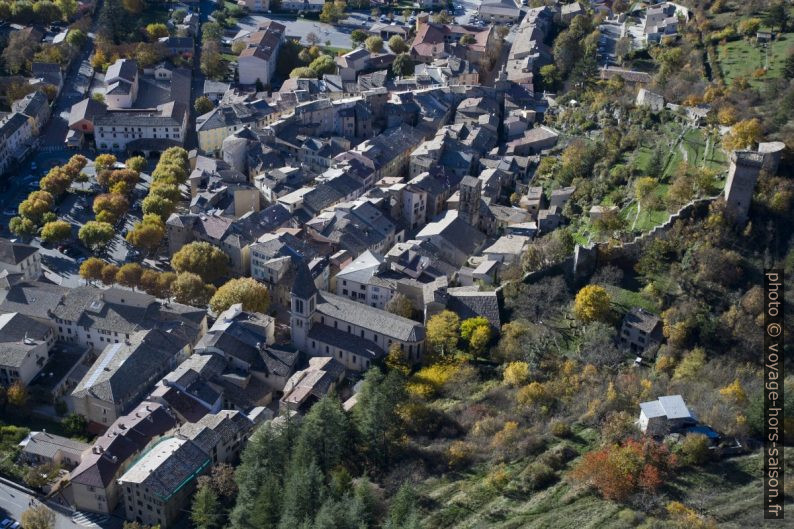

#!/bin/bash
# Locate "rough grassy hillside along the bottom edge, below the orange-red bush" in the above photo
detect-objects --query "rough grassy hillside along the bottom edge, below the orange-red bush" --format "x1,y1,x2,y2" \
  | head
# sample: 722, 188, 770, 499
421, 449, 791, 529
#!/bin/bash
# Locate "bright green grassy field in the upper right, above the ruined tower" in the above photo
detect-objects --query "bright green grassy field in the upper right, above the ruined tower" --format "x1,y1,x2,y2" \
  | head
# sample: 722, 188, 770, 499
717, 33, 794, 86
